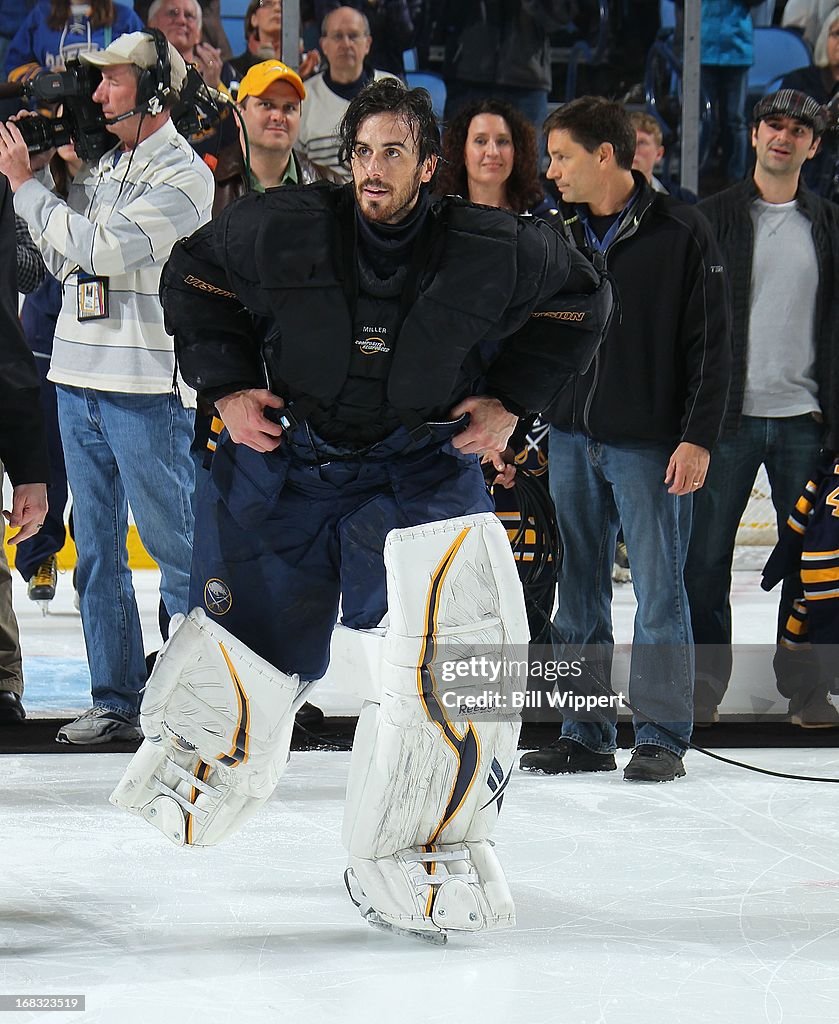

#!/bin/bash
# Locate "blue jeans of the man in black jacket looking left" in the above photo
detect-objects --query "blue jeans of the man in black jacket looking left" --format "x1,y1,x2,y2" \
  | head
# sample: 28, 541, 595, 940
548, 428, 694, 755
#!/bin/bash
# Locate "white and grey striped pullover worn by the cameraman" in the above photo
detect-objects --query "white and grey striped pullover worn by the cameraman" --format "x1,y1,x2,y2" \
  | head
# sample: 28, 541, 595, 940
14, 121, 214, 394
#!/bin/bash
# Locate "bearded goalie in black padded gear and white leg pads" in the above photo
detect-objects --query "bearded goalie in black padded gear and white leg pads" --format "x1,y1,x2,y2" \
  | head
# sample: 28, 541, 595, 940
131, 79, 611, 941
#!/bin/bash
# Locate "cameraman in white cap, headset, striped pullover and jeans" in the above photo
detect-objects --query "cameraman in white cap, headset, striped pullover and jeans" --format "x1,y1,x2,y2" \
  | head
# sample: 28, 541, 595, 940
0, 25, 213, 743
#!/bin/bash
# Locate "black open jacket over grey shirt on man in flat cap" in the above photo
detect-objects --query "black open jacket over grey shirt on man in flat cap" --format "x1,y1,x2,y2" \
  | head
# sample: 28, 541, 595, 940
699, 178, 839, 449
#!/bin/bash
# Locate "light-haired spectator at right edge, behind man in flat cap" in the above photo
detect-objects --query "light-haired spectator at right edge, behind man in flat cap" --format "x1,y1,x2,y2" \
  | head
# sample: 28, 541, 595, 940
781, 6, 839, 202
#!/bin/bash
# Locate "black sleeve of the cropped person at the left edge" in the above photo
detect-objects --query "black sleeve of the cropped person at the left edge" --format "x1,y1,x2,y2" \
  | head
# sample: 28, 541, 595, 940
0, 174, 49, 484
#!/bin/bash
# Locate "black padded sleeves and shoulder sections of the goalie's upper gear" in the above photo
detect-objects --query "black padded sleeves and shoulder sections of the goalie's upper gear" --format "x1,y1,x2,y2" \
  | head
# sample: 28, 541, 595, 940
161, 184, 599, 434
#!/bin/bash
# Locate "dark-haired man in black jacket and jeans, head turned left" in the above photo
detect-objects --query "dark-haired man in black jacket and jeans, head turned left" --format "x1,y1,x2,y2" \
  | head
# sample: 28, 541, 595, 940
521, 96, 730, 781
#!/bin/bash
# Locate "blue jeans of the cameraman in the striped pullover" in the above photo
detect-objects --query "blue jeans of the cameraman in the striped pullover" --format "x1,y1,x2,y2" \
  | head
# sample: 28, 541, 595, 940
56, 385, 194, 716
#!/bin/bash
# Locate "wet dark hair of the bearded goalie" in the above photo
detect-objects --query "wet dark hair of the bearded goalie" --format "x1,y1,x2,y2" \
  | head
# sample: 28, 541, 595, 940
338, 78, 441, 172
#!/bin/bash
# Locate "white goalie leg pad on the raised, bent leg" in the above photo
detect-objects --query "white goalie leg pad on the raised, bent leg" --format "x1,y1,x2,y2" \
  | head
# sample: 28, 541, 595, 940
111, 608, 301, 846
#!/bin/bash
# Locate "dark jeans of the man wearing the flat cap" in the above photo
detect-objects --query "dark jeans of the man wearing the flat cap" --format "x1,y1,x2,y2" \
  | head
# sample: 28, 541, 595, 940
685, 416, 827, 711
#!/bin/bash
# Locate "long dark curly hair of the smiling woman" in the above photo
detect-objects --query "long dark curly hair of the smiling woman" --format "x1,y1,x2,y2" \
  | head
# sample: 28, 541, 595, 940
436, 99, 543, 213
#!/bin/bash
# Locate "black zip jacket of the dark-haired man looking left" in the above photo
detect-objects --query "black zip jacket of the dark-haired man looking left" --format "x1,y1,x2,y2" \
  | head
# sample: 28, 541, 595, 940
550, 172, 730, 451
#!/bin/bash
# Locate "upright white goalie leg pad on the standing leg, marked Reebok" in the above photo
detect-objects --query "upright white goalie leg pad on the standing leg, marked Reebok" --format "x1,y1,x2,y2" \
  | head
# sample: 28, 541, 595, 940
343, 513, 529, 931
